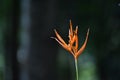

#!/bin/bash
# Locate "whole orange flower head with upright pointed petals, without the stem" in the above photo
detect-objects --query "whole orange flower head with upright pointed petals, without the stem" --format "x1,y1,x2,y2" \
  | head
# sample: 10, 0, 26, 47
52, 20, 89, 59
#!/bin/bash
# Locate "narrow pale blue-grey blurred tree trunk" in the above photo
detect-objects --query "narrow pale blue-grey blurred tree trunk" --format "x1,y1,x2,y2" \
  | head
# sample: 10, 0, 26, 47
17, 0, 31, 80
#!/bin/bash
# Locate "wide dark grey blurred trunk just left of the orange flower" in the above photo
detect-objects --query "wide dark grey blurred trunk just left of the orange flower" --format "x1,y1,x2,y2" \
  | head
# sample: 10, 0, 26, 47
28, 0, 57, 80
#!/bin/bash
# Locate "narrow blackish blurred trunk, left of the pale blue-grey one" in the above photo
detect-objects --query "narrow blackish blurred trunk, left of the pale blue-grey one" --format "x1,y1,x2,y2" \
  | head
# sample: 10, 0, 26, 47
5, 0, 19, 80
